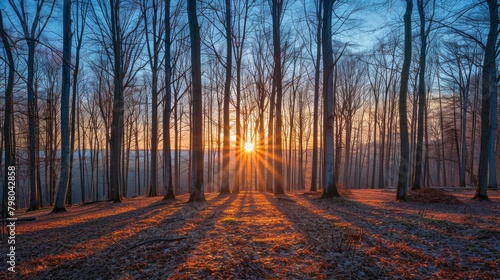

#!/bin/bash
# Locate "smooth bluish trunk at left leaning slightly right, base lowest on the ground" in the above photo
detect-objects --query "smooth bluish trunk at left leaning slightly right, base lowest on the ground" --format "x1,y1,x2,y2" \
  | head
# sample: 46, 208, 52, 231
52, 0, 72, 213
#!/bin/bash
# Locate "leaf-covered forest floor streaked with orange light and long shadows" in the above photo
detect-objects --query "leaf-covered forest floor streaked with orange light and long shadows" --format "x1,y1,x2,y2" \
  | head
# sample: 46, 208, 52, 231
4, 189, 500, 279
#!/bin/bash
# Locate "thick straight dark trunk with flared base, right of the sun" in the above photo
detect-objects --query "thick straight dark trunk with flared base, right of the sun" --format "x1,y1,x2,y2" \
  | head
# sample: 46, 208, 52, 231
321, 0, 340, 198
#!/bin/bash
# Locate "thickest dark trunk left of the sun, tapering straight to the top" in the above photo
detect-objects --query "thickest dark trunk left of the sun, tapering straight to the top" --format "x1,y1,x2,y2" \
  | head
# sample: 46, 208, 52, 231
187, 0, 205, 202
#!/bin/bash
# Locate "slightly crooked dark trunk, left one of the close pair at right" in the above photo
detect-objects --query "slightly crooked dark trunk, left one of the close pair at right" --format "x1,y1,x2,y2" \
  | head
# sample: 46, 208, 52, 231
396, 0, 413, 200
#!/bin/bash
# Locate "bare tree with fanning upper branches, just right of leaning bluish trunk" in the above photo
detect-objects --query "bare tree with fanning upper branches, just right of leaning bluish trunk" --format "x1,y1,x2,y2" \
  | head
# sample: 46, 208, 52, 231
90, 0, 143, 202
